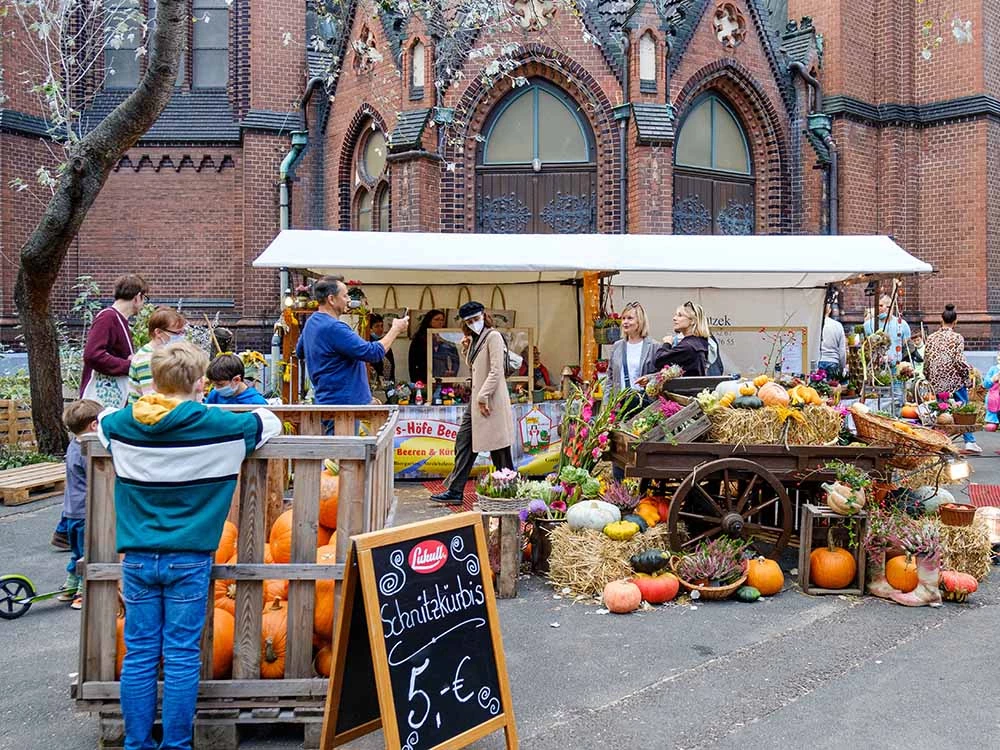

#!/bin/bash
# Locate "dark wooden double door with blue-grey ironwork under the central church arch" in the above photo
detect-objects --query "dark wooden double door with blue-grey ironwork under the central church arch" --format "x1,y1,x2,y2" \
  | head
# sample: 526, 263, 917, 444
476, 165, 597, 234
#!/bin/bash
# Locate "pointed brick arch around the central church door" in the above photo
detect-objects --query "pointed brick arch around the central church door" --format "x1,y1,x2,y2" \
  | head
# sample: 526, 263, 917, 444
441, 44, 621, 232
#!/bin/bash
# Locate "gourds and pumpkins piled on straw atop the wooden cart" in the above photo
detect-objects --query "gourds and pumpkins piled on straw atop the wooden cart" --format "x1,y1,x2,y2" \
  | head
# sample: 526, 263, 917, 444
698, 375, 843, 445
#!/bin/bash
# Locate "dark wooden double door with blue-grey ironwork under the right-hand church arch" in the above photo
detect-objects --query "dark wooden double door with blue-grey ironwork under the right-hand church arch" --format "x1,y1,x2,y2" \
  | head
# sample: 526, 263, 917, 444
673, 172, 755, 234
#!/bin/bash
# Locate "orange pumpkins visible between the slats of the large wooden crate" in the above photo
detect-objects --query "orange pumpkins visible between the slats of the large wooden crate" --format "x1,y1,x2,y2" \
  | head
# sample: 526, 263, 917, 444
115, 465, 340, 680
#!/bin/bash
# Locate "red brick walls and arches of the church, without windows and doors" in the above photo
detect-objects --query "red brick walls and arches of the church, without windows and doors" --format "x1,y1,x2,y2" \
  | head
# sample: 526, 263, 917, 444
0, 0, 1000, 346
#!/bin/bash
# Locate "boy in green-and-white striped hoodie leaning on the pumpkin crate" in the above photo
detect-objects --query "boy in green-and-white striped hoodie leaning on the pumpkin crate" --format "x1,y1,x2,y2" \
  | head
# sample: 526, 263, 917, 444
98, 342, 281, 750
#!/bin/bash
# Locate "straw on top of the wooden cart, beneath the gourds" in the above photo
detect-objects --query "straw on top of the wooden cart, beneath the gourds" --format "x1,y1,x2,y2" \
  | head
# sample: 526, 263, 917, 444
708, 405, 843, 445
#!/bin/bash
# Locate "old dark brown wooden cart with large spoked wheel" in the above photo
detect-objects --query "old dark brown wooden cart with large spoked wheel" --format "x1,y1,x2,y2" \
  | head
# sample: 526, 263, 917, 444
611, 433, 893, 559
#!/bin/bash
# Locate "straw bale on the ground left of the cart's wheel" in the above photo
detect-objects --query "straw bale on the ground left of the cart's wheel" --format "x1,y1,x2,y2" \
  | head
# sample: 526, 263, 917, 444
549, 523, 670, 596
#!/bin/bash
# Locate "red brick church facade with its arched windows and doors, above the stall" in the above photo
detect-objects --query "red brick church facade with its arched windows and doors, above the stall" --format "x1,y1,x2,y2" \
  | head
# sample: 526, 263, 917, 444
0, 0, 1000, 345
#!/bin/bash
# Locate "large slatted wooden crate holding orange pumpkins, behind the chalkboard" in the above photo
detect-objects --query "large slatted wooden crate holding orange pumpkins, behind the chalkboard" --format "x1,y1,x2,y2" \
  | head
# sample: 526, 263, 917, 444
72, 406, 398, 750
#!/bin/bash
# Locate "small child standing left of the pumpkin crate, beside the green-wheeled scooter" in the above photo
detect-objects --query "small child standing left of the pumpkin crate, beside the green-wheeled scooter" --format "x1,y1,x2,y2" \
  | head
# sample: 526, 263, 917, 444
56, 398, 104, 609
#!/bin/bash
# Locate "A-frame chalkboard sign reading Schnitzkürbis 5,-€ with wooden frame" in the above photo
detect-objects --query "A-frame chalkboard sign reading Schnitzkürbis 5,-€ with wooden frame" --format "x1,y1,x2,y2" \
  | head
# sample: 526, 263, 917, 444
322, 513, 517, 750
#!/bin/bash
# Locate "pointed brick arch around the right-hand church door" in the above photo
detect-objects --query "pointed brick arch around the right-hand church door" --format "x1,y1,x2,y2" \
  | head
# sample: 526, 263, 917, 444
674, 58, 792, 234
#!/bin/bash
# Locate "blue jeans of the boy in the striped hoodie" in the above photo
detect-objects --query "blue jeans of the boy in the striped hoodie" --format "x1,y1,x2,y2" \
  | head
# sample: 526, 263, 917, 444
121, 552, 213, 750
